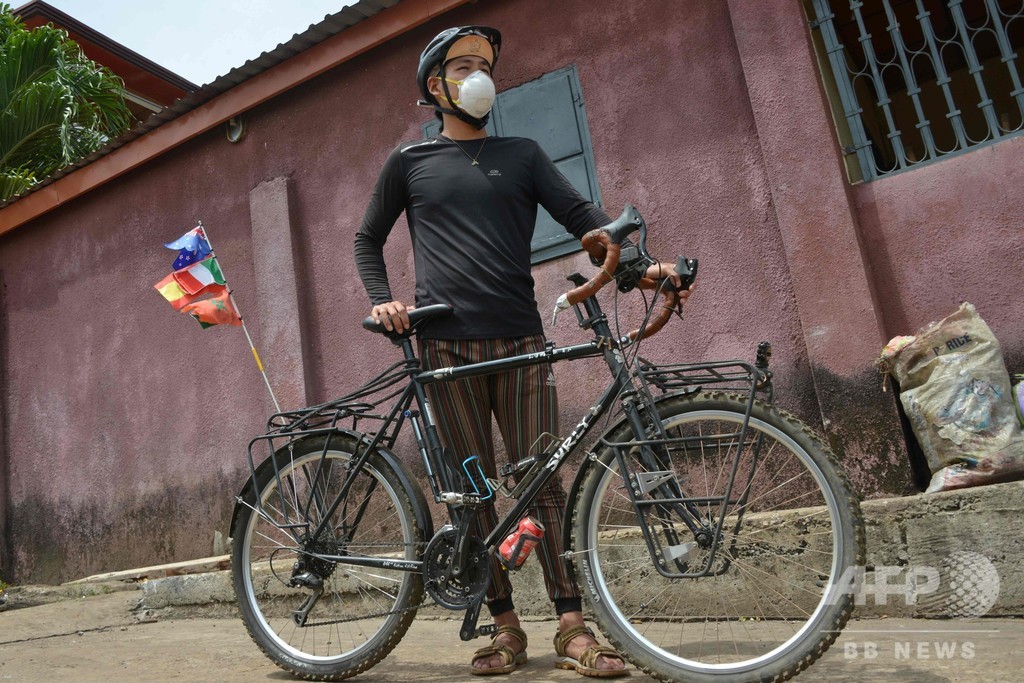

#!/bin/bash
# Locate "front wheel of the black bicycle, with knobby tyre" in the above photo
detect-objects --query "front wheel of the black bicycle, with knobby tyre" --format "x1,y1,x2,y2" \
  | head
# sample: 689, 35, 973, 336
573, 392, 864, 683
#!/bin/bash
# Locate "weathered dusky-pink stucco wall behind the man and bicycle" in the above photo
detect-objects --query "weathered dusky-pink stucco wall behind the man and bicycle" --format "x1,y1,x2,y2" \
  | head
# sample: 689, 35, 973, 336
0, 0, 1024, 582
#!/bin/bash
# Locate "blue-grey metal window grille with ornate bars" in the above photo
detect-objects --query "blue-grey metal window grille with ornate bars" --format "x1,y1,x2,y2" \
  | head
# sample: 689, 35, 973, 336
811, 0, 1024, 180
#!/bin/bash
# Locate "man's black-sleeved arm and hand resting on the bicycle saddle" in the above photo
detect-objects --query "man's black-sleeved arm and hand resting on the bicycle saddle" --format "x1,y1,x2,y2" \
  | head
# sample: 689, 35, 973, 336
352, 147, 409, 332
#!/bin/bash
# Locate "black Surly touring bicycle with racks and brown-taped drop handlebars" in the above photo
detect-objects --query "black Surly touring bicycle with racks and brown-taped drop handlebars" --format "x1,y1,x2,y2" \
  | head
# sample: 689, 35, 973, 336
231, 206, 864, 682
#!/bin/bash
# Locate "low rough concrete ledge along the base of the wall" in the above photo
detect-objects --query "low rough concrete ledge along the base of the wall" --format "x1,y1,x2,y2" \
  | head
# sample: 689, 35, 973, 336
121, 481, 1024, 617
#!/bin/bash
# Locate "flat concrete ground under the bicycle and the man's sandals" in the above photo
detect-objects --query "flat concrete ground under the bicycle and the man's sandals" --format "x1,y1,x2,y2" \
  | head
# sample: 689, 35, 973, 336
0, 590, 1024, 683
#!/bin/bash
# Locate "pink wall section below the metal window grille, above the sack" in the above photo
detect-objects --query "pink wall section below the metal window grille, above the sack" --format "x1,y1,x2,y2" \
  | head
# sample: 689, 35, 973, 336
853, 137, 1024, 372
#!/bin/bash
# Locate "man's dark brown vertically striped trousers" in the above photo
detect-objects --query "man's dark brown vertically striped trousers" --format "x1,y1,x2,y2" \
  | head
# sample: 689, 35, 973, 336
419, 335, 581, 615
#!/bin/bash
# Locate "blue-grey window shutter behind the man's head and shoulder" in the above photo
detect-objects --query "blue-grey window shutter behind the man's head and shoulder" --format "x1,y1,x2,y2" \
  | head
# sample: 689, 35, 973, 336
422, 67, 601, 264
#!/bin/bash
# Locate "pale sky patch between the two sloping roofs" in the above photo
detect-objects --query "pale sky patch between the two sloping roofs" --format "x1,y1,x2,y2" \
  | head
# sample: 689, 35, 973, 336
37, 0, 354, 85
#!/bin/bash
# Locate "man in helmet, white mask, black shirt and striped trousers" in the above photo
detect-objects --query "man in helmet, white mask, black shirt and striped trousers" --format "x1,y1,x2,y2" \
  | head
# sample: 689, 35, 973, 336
354, 27, 688, 677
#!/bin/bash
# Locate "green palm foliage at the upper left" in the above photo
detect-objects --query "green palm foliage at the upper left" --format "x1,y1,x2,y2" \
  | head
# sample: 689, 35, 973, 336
0, 3, 131, 201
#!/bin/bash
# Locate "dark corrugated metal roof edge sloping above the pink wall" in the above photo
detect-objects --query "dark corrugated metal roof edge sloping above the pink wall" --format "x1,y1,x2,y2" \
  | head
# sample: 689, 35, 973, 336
0, 0, 401, 209
